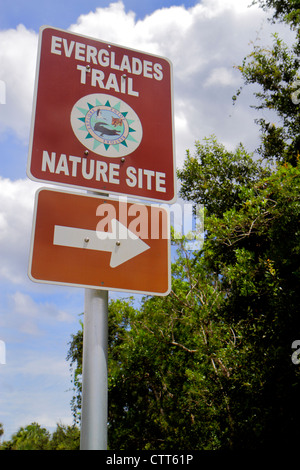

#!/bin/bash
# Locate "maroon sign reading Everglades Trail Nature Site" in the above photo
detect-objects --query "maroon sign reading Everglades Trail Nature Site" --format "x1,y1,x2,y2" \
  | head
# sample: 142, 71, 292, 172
27, 26, 176, 203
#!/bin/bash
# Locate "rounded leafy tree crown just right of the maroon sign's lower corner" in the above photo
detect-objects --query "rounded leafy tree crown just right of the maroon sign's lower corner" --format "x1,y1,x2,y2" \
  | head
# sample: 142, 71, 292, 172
177, 136, 266, 216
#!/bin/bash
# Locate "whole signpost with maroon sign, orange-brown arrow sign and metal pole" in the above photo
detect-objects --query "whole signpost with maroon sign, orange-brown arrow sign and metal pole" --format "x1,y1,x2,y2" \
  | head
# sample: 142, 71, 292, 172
27, 26, 176, 450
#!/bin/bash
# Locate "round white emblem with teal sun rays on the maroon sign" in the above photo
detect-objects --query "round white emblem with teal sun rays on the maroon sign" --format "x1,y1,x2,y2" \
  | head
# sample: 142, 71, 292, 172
71, 94, 143, 158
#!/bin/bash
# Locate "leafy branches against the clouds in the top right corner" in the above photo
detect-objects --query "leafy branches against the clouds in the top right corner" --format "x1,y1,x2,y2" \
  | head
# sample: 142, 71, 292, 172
233, 8, 300, 165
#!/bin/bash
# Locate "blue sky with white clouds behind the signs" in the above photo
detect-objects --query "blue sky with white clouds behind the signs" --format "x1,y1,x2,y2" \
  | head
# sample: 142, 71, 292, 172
0, 0, 288, 439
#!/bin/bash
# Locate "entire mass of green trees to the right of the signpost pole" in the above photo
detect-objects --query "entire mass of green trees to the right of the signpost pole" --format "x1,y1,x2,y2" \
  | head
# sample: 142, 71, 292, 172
66, 1, 300, 450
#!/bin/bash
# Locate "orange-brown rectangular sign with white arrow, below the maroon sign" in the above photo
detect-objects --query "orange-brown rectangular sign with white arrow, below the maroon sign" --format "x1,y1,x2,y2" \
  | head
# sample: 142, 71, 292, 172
29, 188, 170, 295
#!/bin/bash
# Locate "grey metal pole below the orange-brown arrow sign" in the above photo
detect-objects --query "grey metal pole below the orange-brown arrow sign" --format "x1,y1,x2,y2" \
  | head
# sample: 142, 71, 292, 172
80, 289, 108, 450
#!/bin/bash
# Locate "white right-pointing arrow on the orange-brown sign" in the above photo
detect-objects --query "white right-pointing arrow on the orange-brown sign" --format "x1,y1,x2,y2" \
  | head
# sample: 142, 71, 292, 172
53, 219, 150, 268
